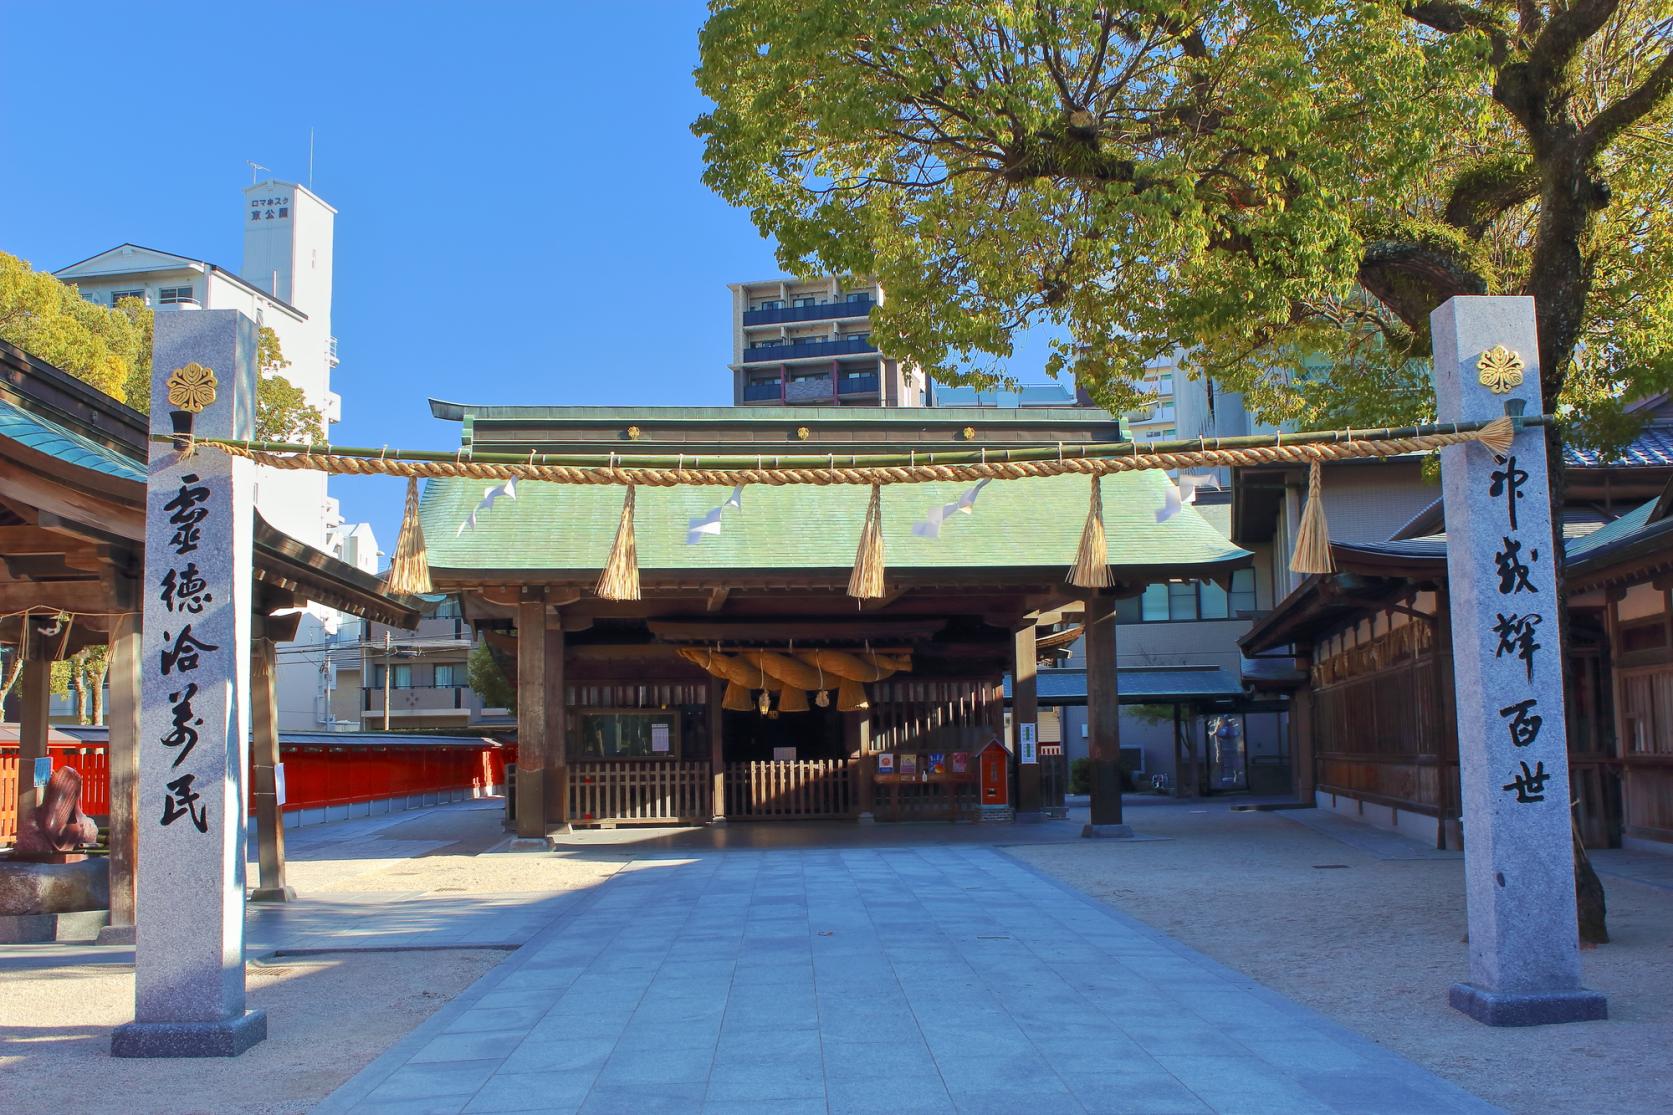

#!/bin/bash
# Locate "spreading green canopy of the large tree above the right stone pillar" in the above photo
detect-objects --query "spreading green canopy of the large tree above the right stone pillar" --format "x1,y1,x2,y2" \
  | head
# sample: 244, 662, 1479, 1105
694, 0, 1673, 440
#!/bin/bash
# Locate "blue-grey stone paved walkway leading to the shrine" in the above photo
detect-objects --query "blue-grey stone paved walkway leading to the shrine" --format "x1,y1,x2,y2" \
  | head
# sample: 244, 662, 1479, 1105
316, 845, 1494, 1115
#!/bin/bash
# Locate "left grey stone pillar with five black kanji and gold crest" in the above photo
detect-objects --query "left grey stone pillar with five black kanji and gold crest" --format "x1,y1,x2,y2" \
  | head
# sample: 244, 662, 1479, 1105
110, 310, 268, 1056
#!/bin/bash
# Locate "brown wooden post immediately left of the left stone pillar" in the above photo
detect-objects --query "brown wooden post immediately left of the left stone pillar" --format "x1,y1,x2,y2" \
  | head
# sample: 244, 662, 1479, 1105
99, 609, 139, 944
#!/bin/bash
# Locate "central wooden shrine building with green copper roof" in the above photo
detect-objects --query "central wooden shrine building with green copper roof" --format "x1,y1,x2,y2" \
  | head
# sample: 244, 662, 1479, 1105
422, 400, 1250, 837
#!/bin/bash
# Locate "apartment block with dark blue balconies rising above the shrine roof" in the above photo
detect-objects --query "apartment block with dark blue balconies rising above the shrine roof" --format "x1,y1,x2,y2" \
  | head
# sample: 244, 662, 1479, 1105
731, 278, 930, 407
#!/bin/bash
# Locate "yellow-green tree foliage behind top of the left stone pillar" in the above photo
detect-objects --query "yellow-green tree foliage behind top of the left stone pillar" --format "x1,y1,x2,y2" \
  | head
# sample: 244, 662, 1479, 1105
0, 251, 325, 440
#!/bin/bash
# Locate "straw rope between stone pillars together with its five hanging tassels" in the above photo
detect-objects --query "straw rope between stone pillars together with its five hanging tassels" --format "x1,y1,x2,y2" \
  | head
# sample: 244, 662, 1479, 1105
179, 417, 1519, 599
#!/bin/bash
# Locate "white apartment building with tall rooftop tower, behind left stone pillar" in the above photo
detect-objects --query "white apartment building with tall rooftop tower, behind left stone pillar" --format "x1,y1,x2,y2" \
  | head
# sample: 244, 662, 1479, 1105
55, 181, 380, 732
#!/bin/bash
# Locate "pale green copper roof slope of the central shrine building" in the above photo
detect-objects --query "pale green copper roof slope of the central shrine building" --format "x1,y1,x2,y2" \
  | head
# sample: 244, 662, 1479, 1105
422, 472, 1248, 574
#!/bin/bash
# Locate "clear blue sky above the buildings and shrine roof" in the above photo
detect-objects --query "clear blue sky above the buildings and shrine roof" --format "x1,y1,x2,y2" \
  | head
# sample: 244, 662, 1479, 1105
0, 0, 1041, 547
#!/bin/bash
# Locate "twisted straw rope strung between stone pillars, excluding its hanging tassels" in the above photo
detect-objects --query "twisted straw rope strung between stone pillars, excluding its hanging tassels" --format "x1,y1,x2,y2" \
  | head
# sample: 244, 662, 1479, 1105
196, 419, 1516, 487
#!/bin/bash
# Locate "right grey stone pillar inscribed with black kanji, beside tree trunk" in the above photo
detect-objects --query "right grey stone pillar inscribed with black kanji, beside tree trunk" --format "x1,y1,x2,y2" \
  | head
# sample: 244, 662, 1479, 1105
1430, 298, 1606, 1026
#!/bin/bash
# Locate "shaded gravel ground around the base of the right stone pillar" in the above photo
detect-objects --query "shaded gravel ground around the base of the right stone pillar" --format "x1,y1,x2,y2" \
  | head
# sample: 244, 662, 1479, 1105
1005, 804, 1673, 1115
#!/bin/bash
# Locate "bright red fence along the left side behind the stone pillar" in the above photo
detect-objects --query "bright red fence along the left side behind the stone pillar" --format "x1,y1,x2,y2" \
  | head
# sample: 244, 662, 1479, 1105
0, 743, 515, 844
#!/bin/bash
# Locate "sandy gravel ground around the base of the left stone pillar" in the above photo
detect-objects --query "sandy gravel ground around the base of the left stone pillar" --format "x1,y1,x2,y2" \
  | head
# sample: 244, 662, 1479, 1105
0, 949, 507, 1115
